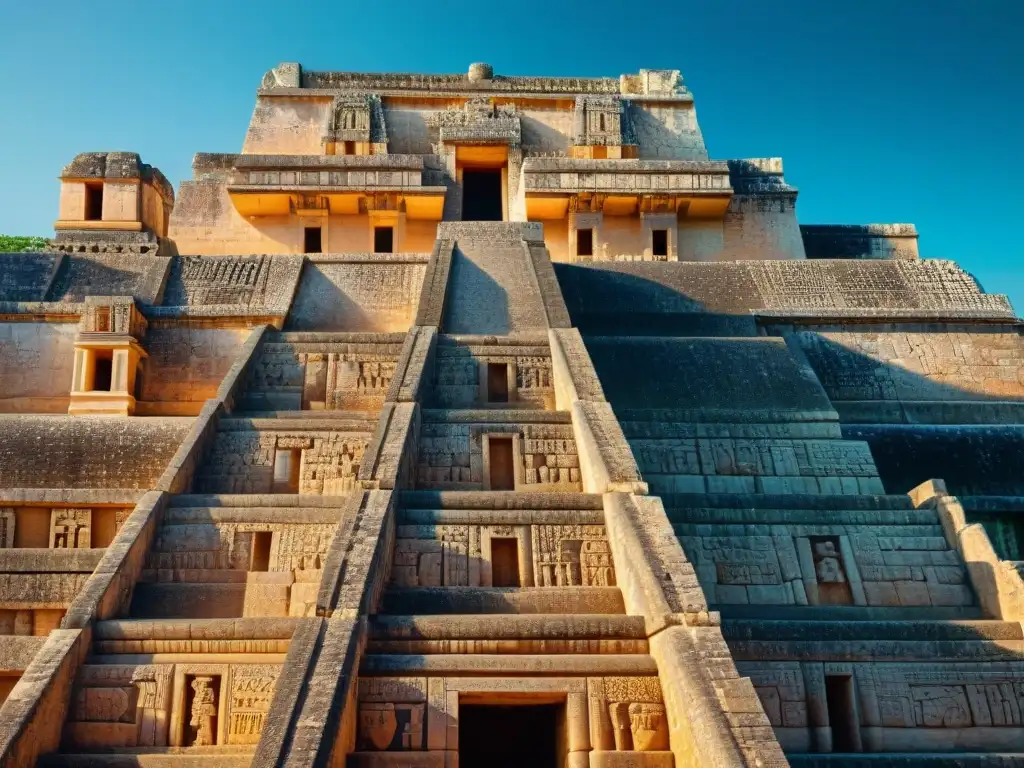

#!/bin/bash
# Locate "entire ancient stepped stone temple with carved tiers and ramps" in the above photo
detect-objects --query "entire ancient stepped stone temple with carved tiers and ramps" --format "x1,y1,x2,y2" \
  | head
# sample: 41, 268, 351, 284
0, 63, 1024, 768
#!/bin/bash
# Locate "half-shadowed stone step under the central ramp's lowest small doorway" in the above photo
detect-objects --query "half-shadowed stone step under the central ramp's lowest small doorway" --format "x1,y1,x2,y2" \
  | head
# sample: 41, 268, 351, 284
379, 587, 626, 615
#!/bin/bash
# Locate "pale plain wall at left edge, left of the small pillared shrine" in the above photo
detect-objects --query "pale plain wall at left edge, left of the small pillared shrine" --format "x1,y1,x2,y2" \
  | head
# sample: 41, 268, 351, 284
0, 322, 78, 414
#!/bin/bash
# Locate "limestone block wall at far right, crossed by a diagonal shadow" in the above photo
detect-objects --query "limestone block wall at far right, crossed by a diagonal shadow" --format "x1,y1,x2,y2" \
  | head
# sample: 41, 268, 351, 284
792, 325, 1024, 401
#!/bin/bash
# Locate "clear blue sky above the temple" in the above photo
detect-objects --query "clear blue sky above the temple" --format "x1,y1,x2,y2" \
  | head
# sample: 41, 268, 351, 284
0, 0, 1024, 314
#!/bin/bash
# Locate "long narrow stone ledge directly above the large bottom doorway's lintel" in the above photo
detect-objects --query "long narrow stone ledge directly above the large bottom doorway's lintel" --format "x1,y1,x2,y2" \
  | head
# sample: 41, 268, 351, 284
359, 653, 657, 677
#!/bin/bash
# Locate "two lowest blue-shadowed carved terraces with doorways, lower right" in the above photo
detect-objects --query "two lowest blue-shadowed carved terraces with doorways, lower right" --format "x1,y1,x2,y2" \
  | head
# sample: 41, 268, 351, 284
664, 494, 1024, 766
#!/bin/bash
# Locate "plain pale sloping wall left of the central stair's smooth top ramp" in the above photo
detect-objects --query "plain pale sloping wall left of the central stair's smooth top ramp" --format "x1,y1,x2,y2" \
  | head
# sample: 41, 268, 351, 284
286, 254, 427, 333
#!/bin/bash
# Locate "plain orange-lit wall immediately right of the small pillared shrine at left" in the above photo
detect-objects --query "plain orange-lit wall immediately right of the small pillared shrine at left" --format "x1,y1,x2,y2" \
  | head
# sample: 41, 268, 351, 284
139, 326, 250, 403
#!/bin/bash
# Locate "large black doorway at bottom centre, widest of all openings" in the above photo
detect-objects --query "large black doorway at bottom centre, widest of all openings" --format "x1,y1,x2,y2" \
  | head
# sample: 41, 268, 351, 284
459, 703, 564, 768
